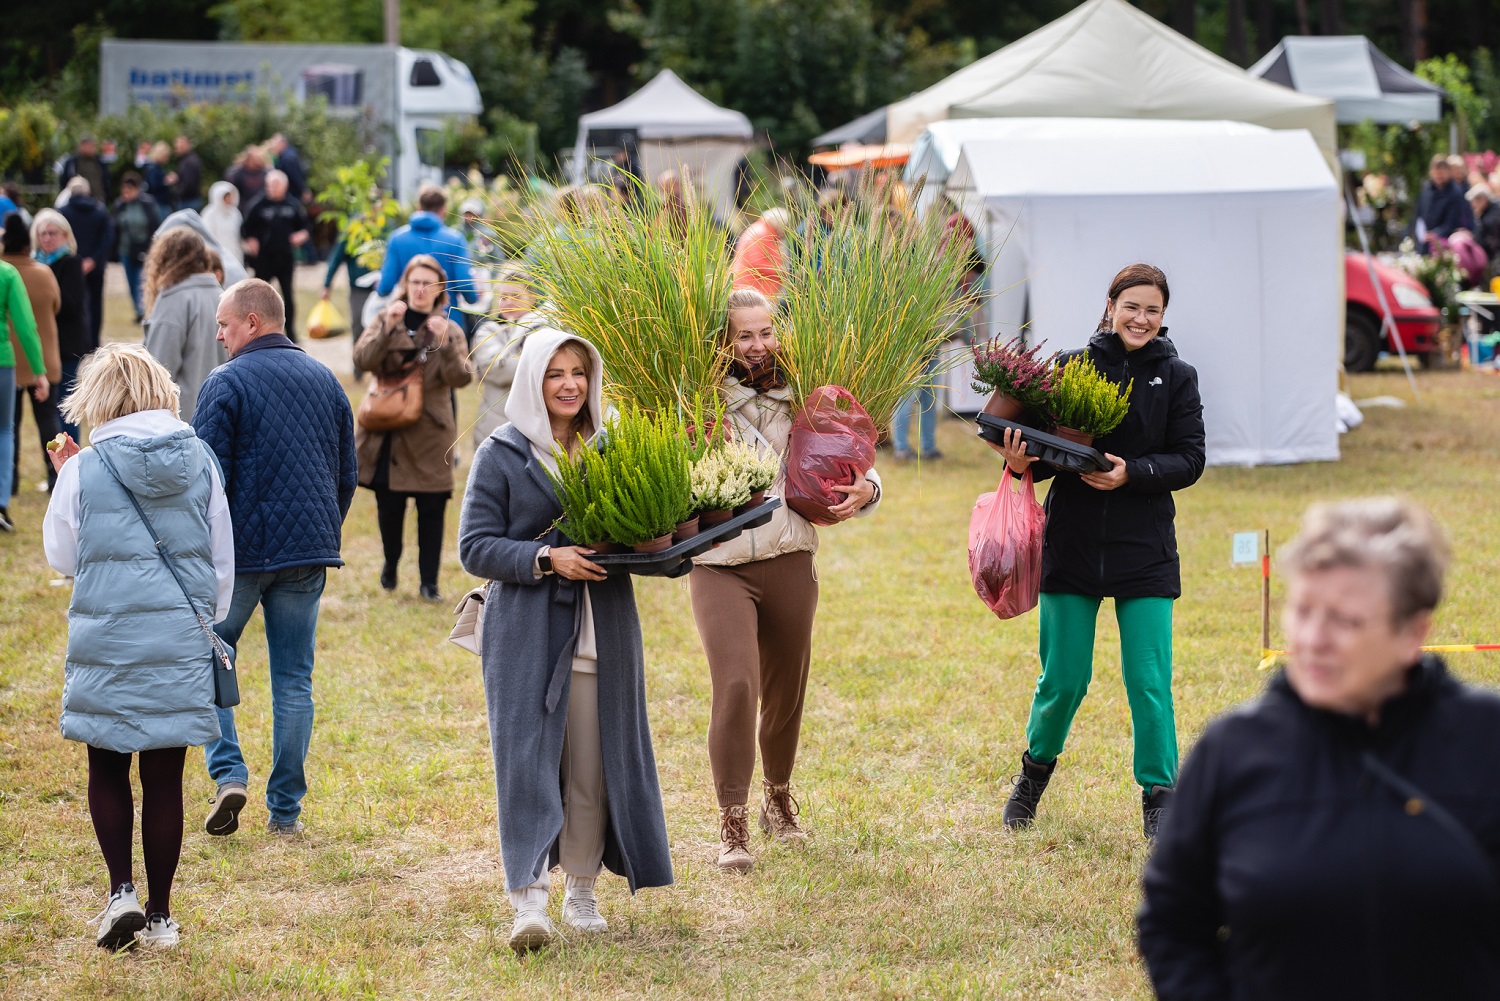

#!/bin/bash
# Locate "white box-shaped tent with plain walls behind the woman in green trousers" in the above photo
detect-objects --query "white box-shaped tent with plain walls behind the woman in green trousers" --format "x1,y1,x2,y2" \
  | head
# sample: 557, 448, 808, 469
948, 132, 1343, 464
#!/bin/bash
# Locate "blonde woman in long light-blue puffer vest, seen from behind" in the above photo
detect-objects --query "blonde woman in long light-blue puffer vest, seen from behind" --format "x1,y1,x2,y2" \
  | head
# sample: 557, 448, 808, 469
42, 344, 234, 950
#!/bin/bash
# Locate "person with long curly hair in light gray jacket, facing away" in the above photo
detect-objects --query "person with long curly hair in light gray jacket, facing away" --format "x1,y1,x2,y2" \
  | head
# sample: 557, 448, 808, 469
143, 227, 230, 422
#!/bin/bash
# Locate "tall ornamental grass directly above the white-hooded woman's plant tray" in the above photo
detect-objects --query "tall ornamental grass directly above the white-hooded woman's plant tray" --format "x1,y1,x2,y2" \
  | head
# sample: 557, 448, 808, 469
527, 185, 729, 413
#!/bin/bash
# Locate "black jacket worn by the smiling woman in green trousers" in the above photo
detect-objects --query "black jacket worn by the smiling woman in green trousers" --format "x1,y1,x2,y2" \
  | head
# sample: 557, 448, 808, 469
1032, 329, 1205, 597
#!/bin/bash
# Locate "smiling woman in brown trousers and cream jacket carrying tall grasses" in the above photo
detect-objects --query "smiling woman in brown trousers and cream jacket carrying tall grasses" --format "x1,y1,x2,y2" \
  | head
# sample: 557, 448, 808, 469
690, 288, 881, 872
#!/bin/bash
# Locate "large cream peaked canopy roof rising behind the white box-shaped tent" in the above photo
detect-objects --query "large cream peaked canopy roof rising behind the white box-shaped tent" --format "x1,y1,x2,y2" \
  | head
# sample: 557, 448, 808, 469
887, 0, 1338, 164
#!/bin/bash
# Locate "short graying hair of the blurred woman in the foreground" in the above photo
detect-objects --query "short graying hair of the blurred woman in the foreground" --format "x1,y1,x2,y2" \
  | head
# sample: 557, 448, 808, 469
1278, 497, 1449, 624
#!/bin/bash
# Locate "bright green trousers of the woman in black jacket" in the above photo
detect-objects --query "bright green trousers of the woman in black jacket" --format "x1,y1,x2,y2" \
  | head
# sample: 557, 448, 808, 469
1026, 591, 1178, 792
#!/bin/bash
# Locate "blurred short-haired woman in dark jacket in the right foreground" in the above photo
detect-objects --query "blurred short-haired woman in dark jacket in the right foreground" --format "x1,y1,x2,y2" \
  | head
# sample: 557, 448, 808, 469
1139, 498, 1500, 1001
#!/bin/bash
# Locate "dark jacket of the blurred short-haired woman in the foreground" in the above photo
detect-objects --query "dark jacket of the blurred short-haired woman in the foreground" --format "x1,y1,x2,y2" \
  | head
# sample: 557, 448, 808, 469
1139, 656, 1500, 1001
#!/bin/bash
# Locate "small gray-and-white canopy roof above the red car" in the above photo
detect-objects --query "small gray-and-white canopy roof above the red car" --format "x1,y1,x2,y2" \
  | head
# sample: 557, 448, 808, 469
1250, 35, 1445, 125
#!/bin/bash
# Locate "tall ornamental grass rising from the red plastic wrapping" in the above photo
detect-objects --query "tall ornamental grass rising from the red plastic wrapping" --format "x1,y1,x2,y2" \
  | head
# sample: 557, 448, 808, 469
779, 186, 978, 428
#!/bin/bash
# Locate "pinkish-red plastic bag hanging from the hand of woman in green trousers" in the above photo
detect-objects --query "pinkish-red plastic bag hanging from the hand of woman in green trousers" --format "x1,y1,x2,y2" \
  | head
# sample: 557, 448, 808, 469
969, 470, 1047, 618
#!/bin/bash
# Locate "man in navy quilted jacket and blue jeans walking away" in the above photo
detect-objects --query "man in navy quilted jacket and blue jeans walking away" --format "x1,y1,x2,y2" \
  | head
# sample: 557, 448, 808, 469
194, 278, 359, 836
